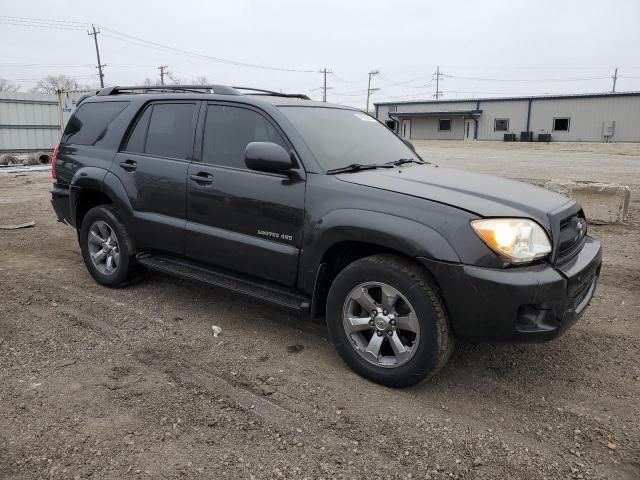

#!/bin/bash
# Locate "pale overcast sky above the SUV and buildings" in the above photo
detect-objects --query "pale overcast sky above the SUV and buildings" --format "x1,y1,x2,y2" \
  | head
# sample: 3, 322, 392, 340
0, 0, 640, 107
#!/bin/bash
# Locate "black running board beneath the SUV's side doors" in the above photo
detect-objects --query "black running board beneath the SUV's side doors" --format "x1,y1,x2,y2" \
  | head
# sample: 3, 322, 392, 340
136, 253, 311, 311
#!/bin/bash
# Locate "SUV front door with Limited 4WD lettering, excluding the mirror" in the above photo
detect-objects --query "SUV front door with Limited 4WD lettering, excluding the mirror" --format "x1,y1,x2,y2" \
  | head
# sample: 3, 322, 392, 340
186, 104, 305, 286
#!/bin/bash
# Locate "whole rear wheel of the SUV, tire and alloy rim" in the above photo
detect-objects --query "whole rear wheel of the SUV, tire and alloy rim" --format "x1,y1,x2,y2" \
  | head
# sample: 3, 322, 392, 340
78, 205, 138, 287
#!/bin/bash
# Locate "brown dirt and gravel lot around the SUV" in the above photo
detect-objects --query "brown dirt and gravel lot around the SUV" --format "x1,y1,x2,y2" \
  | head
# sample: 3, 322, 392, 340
0, 144, 640, 479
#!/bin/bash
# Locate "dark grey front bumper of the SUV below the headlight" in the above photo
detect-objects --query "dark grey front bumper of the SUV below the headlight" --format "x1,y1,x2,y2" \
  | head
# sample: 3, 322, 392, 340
419, 237, 602, 342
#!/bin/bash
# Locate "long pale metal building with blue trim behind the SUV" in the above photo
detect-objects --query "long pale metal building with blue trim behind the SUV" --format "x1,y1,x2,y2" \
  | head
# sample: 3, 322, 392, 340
375, 92, 640, 142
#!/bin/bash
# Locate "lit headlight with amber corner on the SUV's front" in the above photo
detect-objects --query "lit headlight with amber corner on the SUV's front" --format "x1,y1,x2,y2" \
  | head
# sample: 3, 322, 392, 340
471, 218, 551, 263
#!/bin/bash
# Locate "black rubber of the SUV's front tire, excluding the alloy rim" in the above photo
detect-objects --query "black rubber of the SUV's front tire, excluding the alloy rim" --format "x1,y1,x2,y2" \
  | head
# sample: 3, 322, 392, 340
327, 256, 448, 387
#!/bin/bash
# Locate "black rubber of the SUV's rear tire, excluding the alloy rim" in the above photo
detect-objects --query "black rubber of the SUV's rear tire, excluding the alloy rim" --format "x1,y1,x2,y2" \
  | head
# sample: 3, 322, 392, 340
78, 206, 135, 287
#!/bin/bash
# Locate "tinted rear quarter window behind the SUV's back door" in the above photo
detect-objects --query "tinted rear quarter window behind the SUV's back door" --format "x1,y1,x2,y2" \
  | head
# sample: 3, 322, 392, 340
62, 102, 129, 145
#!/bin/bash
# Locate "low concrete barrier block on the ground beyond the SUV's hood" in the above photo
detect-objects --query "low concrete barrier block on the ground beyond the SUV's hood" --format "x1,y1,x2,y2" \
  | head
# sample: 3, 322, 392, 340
544, 180, 631, 224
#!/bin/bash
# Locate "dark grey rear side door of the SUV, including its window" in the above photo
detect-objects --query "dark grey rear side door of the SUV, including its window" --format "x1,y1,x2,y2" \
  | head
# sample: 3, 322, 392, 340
112, 101, 198, 254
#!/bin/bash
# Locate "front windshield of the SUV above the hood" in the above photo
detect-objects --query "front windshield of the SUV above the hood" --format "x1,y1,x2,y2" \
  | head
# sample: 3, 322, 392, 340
280, 106, 420, 170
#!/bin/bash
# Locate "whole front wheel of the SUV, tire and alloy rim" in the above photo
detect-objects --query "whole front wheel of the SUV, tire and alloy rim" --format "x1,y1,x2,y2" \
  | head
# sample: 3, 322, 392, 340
327, 254, 453, 387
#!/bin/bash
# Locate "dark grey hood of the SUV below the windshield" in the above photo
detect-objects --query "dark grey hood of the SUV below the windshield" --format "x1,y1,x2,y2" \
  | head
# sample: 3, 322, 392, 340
337, 164, 574, 228
